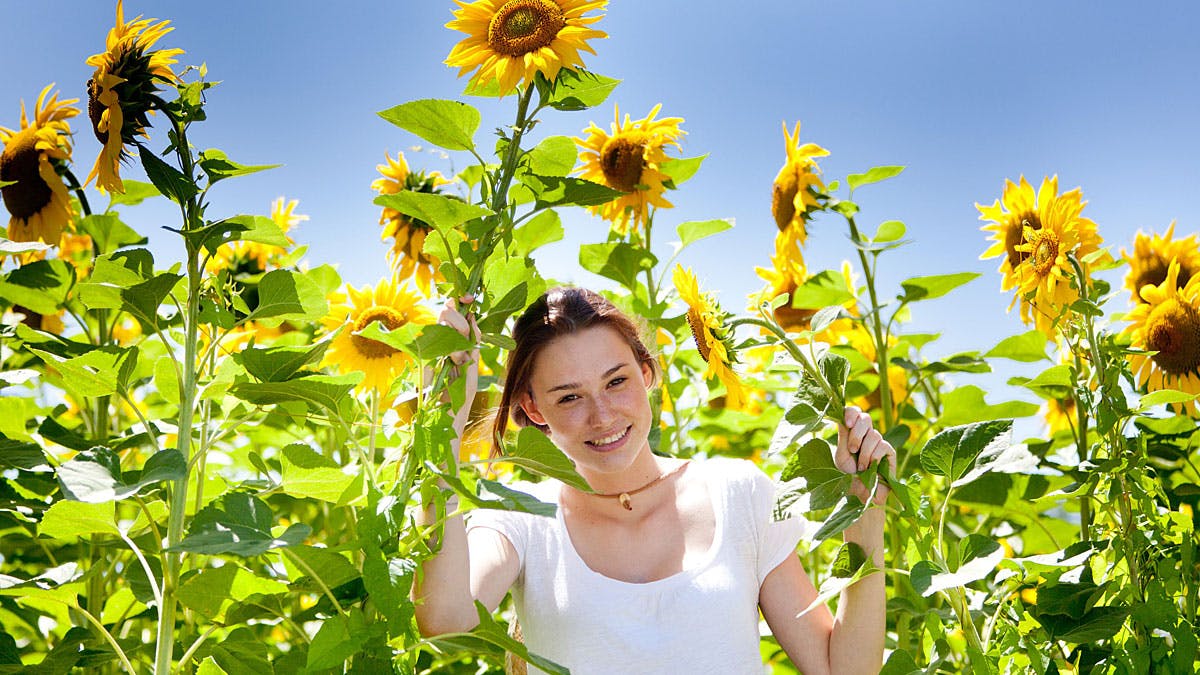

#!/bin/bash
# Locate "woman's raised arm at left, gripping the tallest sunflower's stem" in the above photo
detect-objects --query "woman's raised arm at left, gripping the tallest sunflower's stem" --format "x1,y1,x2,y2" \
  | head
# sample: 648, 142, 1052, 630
413, 298, 520, 637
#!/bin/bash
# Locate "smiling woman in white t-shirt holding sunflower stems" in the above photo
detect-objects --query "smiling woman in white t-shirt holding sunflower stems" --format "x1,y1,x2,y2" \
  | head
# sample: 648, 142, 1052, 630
414, 288, 895, 675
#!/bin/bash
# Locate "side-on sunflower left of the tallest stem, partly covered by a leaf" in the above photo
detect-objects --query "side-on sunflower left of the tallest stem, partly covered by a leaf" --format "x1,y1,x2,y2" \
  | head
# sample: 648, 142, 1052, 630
371, 153, 450, 297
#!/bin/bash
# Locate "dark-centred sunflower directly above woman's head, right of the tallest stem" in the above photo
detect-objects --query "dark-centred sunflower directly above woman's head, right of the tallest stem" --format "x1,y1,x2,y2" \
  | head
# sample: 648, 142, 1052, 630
575, 103, 686, 234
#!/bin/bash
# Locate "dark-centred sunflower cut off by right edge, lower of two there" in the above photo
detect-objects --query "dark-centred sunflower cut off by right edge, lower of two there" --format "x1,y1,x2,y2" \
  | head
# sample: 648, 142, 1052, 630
1122, 261, 1200, 416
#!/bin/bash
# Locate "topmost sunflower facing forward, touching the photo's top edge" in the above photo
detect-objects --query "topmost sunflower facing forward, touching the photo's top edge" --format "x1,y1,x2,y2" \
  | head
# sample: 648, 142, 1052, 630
445, 0, 608, 94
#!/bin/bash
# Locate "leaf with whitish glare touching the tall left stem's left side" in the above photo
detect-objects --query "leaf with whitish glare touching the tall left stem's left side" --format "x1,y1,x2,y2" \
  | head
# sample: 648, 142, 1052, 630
58, 447, 187, 503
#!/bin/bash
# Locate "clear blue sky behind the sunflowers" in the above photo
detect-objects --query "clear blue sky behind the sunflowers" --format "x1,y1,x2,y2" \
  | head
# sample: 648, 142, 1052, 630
0, 0, 1200, 403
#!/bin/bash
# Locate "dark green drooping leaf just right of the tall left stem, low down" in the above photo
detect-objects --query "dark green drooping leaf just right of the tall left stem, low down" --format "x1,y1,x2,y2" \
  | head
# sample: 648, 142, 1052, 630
169, 492, 312, 557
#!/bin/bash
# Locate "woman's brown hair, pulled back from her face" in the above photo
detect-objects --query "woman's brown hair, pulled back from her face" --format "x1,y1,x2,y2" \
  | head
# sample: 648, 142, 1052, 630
492, 286, 659, 455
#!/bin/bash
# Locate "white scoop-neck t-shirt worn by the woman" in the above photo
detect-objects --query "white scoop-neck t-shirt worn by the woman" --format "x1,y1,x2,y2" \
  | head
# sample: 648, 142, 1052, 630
467, 458, 806, 675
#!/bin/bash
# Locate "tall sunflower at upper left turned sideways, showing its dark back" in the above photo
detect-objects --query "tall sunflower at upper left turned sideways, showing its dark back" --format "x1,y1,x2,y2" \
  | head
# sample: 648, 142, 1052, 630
88, 0, 184, 192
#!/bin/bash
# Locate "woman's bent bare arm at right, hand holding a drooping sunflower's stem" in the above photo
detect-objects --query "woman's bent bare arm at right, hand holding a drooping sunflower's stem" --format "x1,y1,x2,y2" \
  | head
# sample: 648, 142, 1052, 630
758, 407, 895, 675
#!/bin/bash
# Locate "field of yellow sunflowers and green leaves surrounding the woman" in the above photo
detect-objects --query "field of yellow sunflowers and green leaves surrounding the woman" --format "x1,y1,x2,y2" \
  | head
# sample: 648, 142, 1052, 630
0, 0, 1200, 675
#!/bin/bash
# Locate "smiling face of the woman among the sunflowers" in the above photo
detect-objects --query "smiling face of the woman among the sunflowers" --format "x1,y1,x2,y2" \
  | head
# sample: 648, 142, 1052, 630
522, 325, 653, 473
